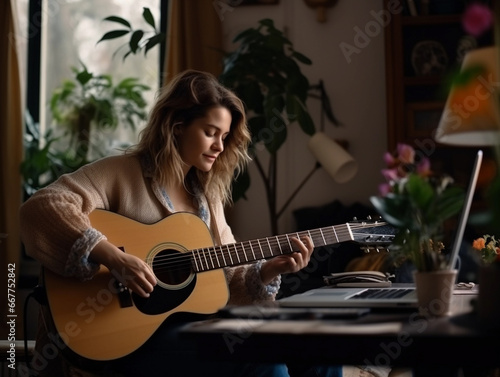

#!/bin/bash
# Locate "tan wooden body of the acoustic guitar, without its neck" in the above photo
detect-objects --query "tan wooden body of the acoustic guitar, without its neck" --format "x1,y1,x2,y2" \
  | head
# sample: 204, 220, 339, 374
43, 210, 229, 361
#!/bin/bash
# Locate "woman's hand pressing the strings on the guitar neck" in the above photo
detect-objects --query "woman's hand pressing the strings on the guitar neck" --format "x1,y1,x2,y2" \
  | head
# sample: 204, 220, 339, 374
260, 236, 314, 285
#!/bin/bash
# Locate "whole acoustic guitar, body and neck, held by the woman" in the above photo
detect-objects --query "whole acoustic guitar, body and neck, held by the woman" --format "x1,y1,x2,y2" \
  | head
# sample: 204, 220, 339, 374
43, 210, 387, 363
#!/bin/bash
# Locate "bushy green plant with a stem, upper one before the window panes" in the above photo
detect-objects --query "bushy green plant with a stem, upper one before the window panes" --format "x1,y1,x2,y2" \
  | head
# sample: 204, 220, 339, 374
50, 63, 150, 160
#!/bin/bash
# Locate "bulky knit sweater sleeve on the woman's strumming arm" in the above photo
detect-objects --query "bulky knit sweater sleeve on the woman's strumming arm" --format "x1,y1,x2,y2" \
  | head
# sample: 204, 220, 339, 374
20, 166, 105, 280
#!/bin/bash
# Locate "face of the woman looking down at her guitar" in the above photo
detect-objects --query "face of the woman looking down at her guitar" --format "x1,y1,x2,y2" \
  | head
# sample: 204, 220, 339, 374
177, 107, 231, 174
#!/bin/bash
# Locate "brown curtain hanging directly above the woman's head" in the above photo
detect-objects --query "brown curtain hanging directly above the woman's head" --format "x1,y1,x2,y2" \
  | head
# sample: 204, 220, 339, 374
163, 0, 223, 82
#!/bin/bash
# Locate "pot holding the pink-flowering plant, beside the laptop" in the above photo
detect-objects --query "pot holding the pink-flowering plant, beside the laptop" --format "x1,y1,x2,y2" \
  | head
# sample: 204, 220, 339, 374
413, 270, 458, 317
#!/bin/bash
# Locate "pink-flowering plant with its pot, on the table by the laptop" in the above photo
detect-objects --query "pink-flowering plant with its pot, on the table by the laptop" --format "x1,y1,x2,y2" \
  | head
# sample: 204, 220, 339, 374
370, 144, 464, 315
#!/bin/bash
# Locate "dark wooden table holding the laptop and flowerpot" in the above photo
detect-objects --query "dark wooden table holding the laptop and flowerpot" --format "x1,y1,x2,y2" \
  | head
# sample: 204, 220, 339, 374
178, 288, 500, 376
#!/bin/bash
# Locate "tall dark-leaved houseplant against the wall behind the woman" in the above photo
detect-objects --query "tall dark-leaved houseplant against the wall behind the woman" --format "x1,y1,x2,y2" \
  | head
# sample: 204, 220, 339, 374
219, 19, 339, 234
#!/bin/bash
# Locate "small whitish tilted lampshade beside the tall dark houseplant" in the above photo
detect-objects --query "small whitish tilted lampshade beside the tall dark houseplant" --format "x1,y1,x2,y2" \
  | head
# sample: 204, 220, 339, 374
308, 132, 358, 183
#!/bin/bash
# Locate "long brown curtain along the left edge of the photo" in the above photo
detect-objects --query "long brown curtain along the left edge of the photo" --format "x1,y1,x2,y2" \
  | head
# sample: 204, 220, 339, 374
0, 0, 23, 339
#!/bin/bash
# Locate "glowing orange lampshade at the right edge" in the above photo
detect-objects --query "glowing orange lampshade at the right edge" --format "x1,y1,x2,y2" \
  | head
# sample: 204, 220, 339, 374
435, 47, 500, 146
